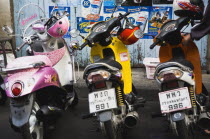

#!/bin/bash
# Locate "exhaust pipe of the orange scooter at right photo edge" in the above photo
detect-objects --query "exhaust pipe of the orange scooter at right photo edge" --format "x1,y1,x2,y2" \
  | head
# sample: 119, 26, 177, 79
198, 112, 210, 129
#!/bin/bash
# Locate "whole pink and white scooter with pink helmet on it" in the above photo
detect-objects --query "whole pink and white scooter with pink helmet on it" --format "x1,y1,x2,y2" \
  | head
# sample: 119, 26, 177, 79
3, 12, 78, 139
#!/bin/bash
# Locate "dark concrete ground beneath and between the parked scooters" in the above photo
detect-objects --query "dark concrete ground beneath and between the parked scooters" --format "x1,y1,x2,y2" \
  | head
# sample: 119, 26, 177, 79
0, 68, 210, 139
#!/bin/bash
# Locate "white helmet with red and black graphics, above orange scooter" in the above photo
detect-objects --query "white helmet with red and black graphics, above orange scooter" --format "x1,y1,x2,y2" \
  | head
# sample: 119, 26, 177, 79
173, 0, 204, 20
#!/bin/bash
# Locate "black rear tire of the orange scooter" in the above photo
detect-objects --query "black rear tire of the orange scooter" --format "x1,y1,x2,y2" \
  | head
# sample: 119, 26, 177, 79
176, 120, 196, 139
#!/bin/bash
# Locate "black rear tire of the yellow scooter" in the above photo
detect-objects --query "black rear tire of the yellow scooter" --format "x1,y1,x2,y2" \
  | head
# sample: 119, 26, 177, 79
104, 120, 124, 139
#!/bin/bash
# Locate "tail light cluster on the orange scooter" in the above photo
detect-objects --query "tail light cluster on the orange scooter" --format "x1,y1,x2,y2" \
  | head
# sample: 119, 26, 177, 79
157, 69, 183, 82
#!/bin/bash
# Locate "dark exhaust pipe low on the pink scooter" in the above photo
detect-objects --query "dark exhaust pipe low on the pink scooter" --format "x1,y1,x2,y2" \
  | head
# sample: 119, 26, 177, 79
36, 105, 62, 121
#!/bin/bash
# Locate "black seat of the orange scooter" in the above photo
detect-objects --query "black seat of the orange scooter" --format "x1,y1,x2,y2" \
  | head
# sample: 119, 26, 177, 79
156, 59, 194, 73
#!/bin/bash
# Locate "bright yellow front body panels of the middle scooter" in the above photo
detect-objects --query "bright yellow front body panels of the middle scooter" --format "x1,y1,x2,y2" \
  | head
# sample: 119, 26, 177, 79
90, 37, 132, 94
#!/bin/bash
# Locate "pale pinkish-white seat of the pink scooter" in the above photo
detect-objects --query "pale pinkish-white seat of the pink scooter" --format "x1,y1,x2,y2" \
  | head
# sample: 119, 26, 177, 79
6, 55, 52, 69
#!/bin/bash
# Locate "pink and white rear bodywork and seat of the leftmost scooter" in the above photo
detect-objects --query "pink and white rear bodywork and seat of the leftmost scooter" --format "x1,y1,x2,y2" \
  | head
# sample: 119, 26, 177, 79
4, 46, 66, 98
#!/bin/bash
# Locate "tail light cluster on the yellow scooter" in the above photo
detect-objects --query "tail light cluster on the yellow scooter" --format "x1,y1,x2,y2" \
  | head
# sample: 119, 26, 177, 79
87, 70, 111, 83
